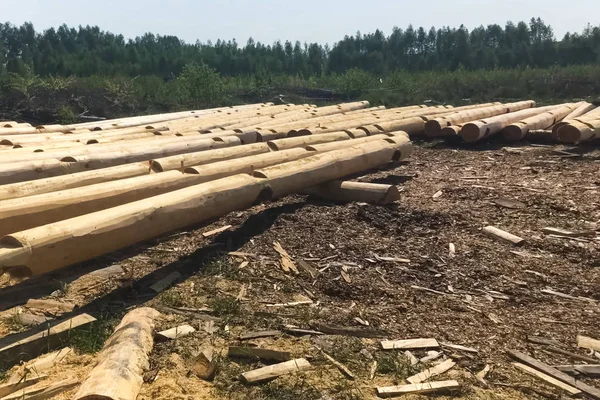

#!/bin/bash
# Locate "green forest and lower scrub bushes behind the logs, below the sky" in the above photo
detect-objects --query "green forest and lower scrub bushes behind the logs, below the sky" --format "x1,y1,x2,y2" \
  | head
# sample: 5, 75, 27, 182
0, 18, 600, 122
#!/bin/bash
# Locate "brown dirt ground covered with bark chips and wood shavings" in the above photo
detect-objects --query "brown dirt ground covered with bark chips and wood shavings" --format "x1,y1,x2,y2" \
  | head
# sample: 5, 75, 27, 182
0, 138, 600, 400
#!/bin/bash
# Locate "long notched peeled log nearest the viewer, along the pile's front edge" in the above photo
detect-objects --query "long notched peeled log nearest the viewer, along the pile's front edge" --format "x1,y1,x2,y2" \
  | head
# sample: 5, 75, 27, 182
0, 139, 405, 275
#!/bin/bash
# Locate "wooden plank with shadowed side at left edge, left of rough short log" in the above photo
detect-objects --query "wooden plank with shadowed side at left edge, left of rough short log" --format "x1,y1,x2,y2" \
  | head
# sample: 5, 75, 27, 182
0, 314, 96, 361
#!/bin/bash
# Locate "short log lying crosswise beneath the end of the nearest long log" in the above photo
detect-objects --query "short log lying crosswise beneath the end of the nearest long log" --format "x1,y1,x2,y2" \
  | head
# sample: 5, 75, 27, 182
304, 181, 400, 204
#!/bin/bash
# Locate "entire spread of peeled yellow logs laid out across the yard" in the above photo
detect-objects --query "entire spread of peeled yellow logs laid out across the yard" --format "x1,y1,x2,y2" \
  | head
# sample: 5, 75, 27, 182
0, 101, 600, 274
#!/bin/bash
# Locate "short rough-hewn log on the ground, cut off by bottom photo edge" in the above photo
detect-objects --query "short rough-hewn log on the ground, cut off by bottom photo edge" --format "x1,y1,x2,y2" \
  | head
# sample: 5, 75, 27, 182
73, 307, 160, 400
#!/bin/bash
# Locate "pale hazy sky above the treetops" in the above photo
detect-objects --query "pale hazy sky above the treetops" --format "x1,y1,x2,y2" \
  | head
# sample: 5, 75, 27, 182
0, 0, 600, 44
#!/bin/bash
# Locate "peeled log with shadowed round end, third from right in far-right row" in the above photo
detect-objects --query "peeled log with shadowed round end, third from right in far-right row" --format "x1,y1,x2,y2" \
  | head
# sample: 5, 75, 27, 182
459, 106, 559, 143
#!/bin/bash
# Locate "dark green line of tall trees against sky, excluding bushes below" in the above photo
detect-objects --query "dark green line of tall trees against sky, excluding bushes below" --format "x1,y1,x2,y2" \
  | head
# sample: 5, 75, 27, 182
0, 18, 600, 80
